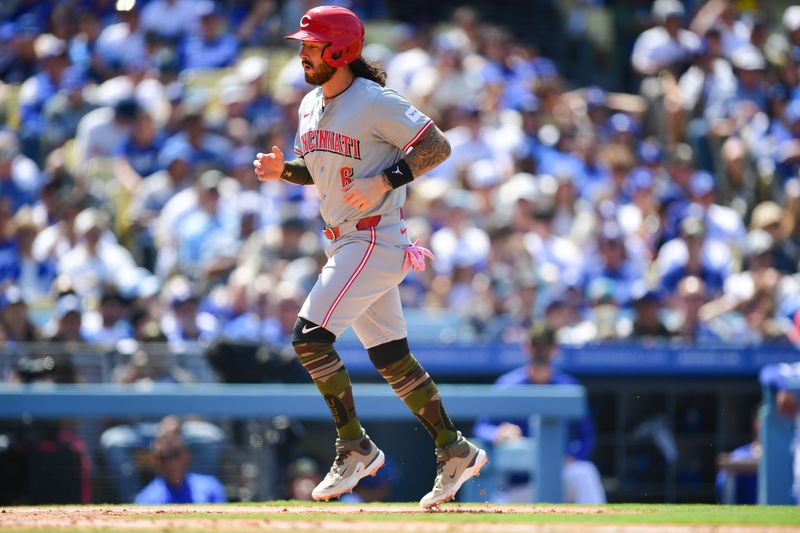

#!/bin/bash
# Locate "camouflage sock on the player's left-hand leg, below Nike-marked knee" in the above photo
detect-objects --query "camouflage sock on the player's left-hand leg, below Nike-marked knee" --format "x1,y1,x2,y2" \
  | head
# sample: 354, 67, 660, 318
294, 343, 363, 440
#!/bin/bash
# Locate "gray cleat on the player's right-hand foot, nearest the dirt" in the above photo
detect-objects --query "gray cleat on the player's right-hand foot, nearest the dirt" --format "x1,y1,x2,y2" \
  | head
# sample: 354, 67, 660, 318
419, 431, 489, 509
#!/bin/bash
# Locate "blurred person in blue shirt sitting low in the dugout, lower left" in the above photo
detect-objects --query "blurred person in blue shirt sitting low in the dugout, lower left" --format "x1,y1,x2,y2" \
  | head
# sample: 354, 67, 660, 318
135, 417, 228, 505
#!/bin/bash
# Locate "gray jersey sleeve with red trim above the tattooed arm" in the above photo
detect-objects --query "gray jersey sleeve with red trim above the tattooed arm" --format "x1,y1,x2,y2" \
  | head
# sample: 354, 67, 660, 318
370, 89, 433, 152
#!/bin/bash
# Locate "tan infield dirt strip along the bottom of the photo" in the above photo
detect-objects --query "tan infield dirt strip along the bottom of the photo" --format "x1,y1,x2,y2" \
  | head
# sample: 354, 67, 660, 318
0, 504, 800, 533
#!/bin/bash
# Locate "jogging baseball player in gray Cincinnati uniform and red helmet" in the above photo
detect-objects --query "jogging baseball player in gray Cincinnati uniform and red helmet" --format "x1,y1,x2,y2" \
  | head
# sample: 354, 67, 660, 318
253, 6, 488, 508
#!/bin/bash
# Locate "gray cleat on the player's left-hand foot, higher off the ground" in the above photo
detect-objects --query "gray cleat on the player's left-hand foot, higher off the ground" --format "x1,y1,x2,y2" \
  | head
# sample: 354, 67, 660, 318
311, 433, 384, 501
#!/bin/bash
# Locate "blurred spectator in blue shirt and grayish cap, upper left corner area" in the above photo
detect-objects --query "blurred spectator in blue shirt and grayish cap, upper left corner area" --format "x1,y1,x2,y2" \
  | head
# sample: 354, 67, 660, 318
19, 33, 69, 162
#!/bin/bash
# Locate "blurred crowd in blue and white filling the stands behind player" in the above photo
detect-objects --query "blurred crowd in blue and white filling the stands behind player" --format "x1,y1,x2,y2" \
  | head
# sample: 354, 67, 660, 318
0, 0, 800, 364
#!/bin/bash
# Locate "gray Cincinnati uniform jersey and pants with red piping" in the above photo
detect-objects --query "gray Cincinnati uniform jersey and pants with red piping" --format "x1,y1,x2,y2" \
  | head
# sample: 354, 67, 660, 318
294, 77, 432, 348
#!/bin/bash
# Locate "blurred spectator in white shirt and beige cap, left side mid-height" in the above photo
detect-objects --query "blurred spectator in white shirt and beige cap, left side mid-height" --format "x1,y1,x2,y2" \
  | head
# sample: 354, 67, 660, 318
58, 208, 136, 299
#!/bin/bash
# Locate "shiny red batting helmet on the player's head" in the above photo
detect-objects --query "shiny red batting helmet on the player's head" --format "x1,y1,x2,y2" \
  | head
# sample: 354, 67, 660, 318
286, 6, 364, 68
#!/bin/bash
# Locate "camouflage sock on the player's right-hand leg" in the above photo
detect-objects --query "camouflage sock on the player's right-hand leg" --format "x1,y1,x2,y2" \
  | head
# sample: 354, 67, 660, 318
378, 353, 458, 446
